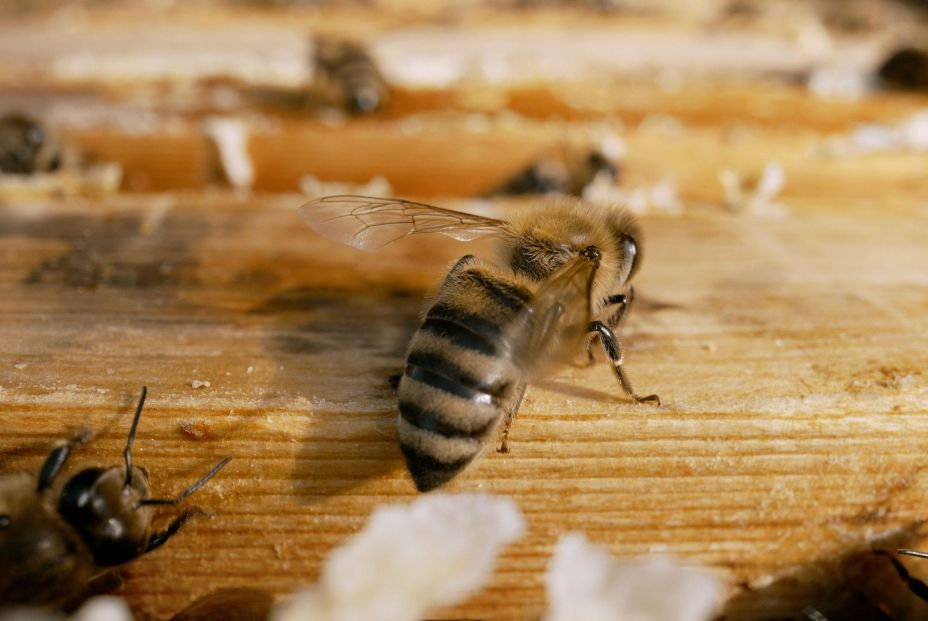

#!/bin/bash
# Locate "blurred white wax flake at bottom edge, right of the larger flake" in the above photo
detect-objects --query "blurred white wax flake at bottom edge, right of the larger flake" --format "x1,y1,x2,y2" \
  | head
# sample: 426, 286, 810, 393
544, 533, 722, 621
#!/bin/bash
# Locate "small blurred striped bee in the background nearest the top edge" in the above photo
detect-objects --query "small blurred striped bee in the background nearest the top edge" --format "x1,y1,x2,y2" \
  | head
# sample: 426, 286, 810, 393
312, 37, 390, 114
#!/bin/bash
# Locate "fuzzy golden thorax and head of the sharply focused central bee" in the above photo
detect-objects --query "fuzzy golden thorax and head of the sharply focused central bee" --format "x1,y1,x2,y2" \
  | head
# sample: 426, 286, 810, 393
501, 197, 642, 318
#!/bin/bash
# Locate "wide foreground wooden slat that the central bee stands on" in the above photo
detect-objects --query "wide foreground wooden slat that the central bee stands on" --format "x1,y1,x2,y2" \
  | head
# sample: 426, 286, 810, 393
0, 190, 928, 618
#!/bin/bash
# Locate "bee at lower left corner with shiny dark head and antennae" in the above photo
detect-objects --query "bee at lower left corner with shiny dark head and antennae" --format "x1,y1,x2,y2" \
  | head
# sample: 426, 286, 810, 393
0, 388, 231, 605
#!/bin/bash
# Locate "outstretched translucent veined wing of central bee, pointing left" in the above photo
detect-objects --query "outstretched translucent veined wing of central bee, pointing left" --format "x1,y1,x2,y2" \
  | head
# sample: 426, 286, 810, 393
300, 195, 511, 250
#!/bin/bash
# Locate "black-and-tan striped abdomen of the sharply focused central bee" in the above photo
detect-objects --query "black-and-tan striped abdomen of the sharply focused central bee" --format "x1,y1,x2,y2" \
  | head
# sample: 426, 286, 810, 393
399, 256, 532, 491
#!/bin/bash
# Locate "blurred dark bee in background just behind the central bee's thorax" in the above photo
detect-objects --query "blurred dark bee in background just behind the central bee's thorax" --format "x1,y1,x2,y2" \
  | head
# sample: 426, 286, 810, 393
487, 149, 619, 196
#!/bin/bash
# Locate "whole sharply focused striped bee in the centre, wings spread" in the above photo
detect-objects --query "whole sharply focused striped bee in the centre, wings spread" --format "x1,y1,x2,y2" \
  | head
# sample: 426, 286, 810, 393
300, 196, 660, 491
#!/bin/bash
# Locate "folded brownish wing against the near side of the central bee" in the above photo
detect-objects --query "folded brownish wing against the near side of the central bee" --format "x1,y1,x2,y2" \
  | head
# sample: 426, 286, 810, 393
505, 255, 598, 379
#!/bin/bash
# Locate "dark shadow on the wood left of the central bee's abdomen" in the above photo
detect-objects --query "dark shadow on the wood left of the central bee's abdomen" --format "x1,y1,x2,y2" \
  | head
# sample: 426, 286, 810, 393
252, 287, 423, 503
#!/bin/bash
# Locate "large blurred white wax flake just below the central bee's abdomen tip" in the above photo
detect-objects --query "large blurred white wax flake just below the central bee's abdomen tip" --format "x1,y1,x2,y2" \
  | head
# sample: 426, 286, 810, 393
271, 494, 525, 621
